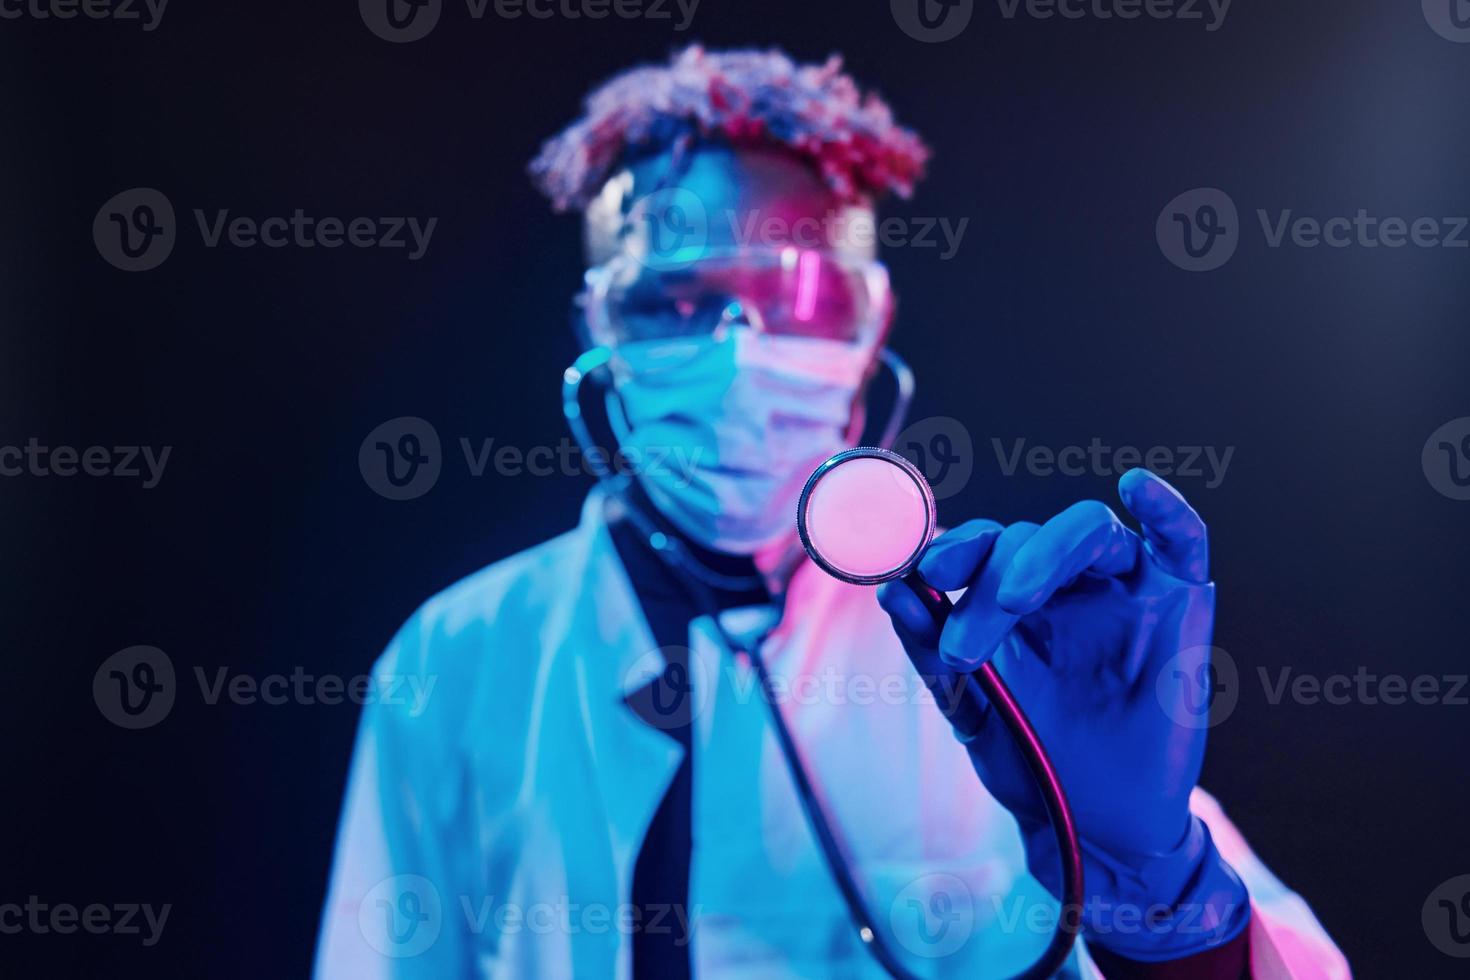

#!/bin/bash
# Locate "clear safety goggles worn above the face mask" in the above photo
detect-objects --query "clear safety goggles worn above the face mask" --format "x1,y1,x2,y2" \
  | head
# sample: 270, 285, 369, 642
581, 247, 891, 347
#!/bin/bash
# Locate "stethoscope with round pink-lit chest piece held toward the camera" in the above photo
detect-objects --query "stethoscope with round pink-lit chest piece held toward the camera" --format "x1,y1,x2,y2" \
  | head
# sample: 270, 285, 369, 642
562, 348, 1083, 980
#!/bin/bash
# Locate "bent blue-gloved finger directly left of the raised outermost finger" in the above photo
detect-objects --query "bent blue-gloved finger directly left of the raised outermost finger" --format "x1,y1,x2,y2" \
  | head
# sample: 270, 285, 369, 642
995, 500, 1141, 616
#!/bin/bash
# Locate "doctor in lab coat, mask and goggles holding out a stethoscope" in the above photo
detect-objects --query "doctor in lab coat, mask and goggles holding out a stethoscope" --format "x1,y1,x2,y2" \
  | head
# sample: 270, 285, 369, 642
316, 47, 1349, 980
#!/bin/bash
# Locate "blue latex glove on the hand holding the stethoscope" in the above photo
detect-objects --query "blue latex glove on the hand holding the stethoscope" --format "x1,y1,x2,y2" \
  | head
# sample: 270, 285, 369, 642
879, 469, 1250, 962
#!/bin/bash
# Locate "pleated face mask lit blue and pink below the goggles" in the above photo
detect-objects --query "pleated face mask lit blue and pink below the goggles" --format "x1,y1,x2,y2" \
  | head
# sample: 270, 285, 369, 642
610, 326, 873, 554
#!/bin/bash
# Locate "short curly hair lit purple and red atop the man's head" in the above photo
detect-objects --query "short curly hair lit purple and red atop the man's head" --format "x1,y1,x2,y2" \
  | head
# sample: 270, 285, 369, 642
529, 46, 929, 212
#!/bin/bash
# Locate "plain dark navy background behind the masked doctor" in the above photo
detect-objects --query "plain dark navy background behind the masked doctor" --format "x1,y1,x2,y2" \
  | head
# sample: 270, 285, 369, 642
0, 0, 1470, 977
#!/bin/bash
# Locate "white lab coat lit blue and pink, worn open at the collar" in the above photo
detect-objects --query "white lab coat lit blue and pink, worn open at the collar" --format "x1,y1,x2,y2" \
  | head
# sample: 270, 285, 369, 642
316, 492, 1349, 980
